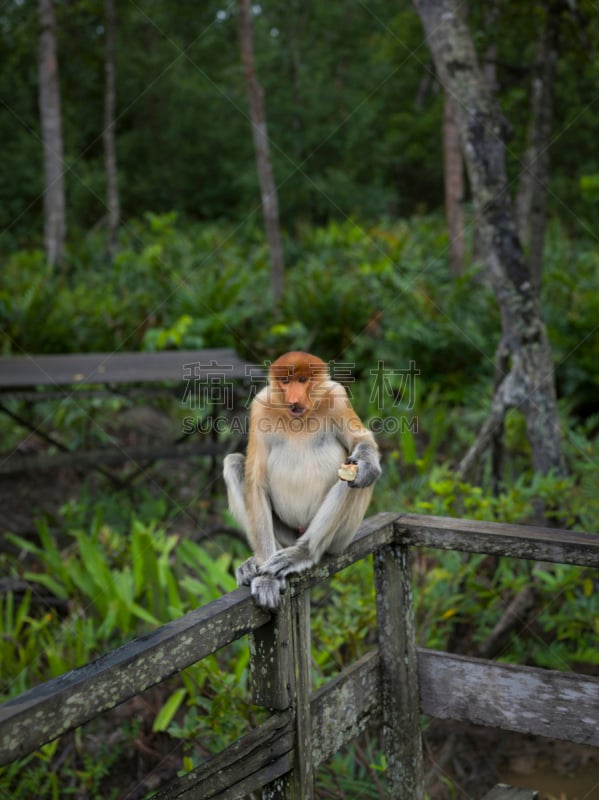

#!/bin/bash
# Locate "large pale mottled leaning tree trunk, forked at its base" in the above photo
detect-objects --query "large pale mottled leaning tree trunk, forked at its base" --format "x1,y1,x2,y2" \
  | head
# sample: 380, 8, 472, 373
414, 0, 565, 482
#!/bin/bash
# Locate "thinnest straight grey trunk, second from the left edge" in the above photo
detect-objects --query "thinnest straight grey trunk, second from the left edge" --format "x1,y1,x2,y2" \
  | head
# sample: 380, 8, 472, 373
102, 0, 121, 258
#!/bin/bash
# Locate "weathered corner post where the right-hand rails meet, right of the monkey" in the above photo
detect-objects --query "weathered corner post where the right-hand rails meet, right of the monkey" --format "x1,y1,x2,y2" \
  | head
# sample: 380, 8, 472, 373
374, 544, 424, 800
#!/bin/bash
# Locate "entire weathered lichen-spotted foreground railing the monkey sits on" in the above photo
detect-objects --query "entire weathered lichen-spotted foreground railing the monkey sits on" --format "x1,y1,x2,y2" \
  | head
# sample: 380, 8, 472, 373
0, 513, 599, 800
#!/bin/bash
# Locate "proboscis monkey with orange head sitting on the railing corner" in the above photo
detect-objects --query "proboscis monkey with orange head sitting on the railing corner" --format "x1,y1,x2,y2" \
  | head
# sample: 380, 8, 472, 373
224, 352, 381, 609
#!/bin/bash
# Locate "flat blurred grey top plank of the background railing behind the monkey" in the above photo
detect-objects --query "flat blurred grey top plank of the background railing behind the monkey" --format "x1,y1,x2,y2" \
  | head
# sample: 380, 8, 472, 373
0, 348, 247, 389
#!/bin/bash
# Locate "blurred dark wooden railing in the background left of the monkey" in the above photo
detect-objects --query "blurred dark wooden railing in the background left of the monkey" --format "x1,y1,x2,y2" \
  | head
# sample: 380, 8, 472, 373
0, 348, 251, 476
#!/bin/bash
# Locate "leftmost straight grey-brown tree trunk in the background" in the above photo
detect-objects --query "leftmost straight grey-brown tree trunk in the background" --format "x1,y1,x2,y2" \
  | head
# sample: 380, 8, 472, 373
38, 0, 66, 265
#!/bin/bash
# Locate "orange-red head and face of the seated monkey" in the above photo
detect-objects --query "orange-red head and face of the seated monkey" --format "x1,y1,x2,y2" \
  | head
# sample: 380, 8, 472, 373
268, 350, 329, 417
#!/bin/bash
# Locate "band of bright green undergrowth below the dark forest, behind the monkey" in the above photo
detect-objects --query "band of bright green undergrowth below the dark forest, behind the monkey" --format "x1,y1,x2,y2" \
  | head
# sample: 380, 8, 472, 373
0, 213, 599, 410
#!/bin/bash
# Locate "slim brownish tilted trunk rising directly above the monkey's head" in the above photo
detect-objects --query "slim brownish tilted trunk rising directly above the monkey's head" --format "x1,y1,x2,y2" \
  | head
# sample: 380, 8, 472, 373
239, 0, 284, 304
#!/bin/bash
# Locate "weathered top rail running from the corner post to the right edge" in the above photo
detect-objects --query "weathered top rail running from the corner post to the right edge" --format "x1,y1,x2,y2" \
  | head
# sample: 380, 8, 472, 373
396, 514, 599, 567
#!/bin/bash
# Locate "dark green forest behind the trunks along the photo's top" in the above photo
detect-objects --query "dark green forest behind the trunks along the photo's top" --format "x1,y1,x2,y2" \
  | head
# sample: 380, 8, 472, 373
0, 0, 599, 247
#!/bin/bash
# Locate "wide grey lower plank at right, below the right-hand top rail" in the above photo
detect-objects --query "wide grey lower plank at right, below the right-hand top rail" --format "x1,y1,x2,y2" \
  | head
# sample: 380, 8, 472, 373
418, 650, 599, 747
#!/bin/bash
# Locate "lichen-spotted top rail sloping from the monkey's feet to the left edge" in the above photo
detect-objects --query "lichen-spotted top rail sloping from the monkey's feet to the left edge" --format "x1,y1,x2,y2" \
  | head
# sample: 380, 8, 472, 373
0, 589, 269, 764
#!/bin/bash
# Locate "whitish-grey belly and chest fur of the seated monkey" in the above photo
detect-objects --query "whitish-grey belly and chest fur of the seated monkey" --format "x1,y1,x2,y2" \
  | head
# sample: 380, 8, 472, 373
266, 433, 347, 531
